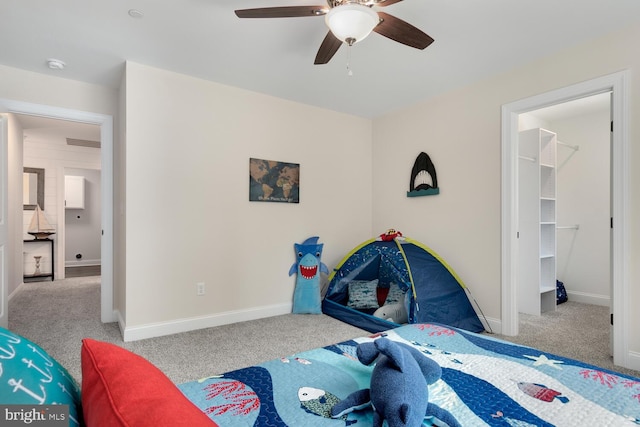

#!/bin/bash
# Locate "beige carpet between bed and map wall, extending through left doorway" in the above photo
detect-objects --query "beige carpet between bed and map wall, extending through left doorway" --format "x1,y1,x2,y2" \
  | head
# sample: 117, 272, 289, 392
9, 276, 368, 384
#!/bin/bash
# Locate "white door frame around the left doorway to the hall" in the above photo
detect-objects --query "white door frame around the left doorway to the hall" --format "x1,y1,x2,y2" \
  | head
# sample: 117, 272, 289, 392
0, 99, 117, 323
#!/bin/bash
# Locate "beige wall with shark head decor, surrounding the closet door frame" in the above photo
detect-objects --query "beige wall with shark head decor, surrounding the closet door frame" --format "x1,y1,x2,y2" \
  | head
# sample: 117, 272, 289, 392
373, 25, 640, 364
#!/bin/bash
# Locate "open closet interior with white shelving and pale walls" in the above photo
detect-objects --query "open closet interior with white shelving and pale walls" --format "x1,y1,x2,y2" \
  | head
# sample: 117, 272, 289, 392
518, 93, 611, 315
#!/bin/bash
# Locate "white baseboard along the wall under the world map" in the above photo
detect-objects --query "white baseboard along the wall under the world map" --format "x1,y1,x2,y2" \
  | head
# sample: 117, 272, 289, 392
118, 303, 293, 342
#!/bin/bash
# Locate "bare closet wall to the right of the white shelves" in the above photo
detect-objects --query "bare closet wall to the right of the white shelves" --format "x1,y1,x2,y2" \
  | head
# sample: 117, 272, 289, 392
550, 111, 611, 306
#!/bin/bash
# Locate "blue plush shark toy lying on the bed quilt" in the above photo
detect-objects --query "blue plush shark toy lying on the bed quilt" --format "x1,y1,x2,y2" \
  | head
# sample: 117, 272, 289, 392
331, 338, 461, 427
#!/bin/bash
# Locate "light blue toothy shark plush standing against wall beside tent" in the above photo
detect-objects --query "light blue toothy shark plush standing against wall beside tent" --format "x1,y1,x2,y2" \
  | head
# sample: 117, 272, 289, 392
289, 236, 329, 314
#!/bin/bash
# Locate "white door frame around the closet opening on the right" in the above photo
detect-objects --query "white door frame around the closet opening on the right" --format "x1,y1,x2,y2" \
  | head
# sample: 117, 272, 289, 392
501, 70, 630, 367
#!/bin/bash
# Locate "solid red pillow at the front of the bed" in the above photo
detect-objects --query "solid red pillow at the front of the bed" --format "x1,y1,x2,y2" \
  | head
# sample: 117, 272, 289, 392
81, 339, 216, 427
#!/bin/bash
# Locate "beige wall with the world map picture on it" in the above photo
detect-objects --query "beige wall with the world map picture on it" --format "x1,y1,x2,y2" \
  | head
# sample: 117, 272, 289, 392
125, 63, 372, 339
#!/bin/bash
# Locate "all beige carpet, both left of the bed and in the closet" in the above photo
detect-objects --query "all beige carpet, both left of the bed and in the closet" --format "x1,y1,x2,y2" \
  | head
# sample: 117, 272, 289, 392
9, 276, 640, 383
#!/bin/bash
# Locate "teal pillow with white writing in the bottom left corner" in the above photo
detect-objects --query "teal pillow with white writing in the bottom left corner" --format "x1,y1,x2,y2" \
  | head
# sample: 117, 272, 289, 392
0, 328, 83, 427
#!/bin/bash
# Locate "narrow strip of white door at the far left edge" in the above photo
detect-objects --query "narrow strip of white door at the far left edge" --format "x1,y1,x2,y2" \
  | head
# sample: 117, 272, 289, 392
0, 114, 9, 328
